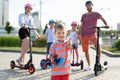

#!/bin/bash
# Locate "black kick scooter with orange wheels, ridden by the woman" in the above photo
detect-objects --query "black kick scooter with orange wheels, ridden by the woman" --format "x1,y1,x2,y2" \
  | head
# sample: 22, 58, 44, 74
10, 28, 36, 74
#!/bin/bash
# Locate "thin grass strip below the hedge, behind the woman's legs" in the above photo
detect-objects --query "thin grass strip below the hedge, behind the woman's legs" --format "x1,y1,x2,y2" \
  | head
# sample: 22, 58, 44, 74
0, 47, 46, 52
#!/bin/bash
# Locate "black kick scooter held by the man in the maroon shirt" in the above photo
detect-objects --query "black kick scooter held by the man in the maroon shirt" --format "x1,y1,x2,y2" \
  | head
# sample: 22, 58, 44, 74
92, 26, 108, 76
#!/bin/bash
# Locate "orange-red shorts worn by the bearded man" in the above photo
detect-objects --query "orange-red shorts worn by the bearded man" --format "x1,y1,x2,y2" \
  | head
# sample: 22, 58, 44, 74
81, 35, 97, 53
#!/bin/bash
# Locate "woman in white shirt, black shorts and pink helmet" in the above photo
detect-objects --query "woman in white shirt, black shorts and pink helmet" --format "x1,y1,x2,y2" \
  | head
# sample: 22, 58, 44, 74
16, 3, 40, 66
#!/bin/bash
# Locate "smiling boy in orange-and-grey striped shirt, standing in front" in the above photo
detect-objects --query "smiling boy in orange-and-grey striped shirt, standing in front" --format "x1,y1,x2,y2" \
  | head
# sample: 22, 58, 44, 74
49, 24, 72, 80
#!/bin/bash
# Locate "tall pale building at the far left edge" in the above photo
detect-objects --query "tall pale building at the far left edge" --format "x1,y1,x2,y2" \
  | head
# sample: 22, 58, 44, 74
0, 0, 9, 26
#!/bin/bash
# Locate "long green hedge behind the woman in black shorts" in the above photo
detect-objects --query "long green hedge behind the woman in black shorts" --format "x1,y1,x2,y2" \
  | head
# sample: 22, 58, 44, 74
0, 36, 47, 47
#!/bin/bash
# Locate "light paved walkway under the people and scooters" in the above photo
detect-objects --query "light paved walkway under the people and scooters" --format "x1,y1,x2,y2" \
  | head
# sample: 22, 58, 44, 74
0, 46, 120, 80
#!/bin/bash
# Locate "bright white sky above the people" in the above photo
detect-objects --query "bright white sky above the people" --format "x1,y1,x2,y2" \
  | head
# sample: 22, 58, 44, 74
9, 0, 120, 29
